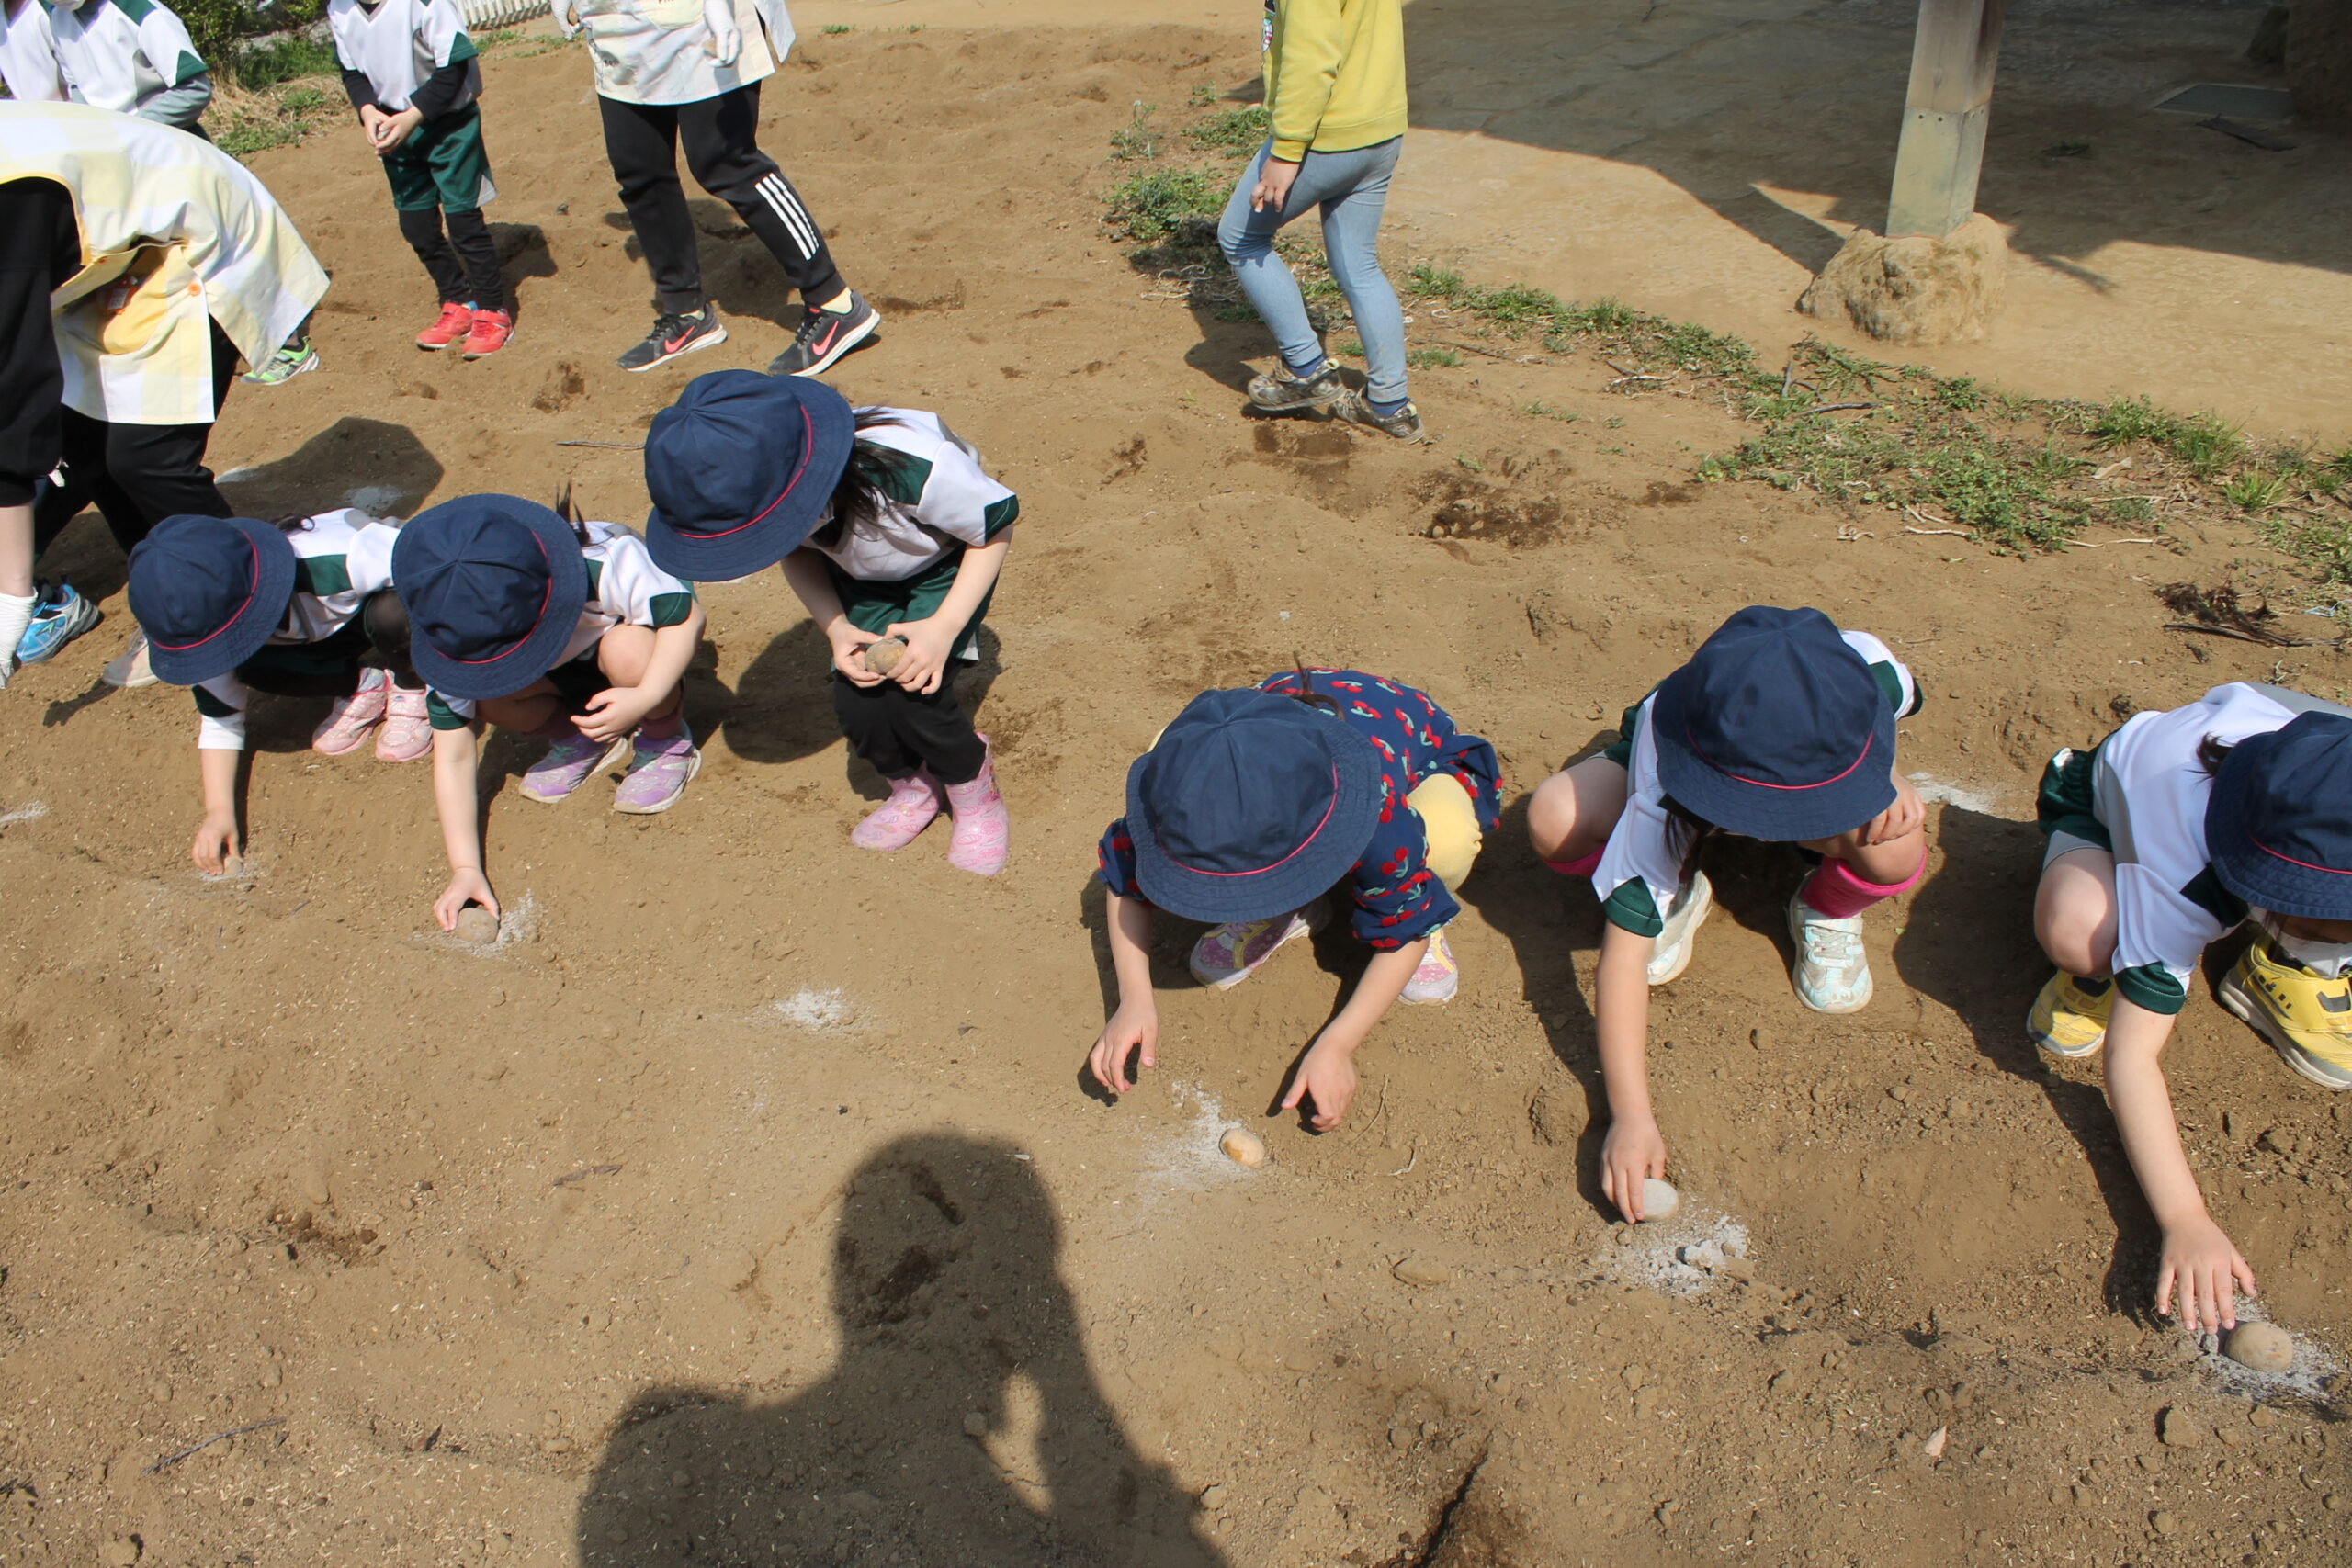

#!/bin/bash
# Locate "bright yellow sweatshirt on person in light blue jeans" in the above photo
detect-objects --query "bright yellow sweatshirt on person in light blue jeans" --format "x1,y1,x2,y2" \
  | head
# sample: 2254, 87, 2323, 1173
1265, 0, 1404, 163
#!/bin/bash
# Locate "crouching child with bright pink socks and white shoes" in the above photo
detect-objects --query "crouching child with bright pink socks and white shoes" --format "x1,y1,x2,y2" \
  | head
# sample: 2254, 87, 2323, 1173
1526, 604, 1927, 1220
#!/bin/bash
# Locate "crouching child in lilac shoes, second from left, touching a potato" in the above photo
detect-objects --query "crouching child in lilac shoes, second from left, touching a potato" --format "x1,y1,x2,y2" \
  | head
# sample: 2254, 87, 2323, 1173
393, 487, 703, 931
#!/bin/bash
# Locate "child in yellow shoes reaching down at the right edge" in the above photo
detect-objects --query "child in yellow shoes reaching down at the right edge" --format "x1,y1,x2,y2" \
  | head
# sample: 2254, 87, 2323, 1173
2025, 684, 2352, 1331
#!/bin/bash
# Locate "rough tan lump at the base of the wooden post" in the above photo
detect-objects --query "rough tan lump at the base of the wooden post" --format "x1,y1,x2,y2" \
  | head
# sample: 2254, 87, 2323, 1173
1797, 211, 2008, 345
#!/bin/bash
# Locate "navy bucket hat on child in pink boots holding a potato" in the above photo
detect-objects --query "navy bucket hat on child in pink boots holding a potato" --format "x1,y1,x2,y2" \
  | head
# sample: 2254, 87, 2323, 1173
644, 369, 856, 583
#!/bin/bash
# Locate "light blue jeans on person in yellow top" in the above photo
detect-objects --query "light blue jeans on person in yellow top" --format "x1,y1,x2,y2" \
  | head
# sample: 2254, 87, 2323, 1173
1216, 136, 1404, 402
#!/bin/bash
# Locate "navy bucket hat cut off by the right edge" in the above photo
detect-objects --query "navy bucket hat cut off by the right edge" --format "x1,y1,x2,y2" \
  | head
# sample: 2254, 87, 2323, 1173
2206, 712, 2352, 919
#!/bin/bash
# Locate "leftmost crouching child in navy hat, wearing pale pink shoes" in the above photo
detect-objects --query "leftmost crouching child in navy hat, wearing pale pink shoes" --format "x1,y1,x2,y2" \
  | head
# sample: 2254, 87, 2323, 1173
130, 508, 430, 877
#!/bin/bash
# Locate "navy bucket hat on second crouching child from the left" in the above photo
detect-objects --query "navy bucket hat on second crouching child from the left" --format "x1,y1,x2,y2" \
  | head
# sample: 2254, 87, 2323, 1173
393, 496, 588, 701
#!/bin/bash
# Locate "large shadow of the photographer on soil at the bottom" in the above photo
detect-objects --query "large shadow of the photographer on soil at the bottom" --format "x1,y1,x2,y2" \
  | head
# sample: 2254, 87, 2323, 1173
579, 1134, 1226, 1568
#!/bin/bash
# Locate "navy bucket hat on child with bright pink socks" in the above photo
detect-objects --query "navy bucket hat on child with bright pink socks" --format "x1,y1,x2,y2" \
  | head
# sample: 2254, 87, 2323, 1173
1651, 604, 1895, 844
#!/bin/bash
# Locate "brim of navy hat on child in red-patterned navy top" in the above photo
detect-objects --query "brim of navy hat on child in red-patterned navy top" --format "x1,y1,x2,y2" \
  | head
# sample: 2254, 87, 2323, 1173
1126, 719, 1381, 924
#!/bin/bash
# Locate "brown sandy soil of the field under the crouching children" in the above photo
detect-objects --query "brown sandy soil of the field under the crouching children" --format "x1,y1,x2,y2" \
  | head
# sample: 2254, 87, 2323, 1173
0, 0, 2352, 1568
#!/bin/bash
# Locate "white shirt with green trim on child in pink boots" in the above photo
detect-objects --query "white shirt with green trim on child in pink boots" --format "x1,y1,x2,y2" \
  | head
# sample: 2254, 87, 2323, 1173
809, 409, 1021, 583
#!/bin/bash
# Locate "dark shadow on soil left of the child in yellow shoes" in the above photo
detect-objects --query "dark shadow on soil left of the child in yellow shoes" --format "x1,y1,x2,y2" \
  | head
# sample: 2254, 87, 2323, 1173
1894, 804, 2162, 1324
